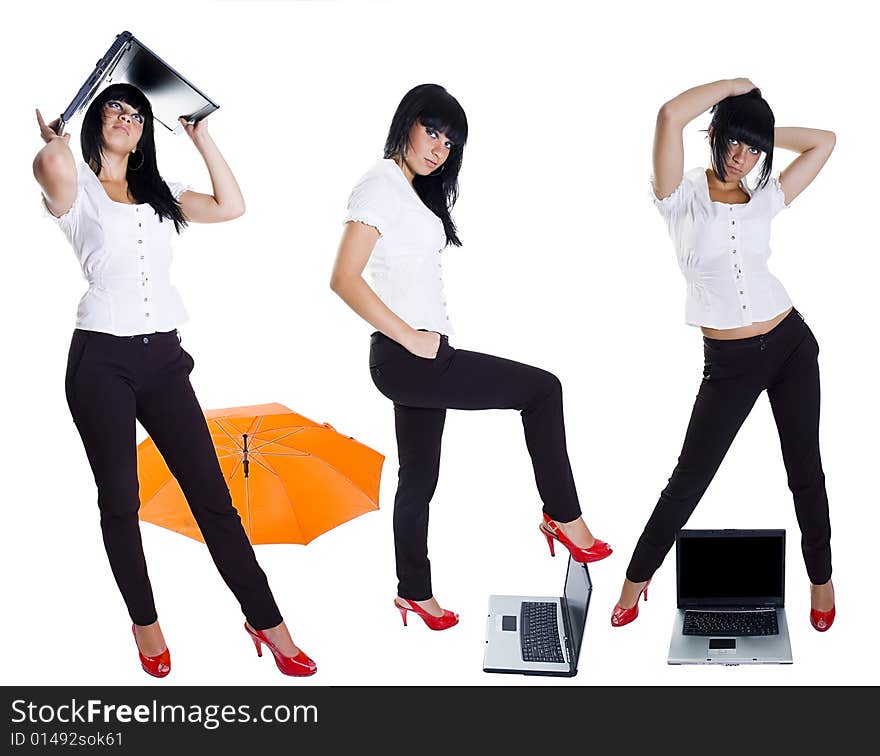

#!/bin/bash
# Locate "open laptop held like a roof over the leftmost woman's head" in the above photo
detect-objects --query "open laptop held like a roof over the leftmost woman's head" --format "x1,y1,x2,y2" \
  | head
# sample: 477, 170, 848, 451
57, 31, 220, 134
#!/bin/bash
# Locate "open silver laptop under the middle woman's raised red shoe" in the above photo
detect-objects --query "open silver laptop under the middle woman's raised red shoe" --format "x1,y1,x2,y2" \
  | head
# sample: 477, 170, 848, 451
483, 556, 593, 677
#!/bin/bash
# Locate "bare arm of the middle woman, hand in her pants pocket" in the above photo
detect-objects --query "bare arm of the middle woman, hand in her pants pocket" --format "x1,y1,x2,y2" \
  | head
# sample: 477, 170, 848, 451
330, 221, 440, 358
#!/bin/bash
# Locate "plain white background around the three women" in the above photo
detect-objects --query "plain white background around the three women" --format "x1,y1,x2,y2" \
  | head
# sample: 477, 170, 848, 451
0, 2, 880, 686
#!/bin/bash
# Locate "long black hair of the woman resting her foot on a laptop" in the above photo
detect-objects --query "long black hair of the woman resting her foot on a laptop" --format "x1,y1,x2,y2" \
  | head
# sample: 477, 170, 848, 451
385, 84, 467, 247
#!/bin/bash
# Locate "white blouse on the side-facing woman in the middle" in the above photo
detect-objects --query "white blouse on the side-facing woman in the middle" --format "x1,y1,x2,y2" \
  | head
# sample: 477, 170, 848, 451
345, 159, 452, 335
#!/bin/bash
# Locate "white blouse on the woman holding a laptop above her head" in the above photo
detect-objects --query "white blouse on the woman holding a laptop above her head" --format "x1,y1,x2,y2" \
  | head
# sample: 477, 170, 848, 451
43, 163, 189, 336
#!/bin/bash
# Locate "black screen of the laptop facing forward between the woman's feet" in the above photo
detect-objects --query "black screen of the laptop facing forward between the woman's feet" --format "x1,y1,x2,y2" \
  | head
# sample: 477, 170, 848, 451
677, 531, 785, 606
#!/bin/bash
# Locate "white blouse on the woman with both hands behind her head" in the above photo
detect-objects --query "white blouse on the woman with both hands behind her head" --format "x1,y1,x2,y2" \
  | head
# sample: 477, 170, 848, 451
654, 168, 791, 329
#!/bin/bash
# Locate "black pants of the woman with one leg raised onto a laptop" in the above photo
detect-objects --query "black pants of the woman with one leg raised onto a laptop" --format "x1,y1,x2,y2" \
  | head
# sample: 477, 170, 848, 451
370, 332, 581, 601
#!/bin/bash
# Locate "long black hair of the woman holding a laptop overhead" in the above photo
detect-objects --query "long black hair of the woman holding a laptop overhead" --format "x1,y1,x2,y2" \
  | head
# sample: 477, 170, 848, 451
79, 84, 186, 233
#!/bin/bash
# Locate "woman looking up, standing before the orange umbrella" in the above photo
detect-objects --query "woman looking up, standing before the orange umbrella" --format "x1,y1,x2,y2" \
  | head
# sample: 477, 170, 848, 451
33, 84, 316, 677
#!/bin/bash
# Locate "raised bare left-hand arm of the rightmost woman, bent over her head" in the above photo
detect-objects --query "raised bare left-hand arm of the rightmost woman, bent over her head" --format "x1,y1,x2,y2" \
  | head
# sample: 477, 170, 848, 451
654, 79, 755, 199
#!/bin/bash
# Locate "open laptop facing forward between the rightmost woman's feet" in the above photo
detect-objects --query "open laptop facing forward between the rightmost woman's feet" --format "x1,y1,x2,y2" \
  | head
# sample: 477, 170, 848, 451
668, 530, 792, 665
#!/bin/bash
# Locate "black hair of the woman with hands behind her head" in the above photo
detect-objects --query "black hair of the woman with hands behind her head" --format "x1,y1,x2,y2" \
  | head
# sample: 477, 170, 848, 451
709, 87, 776, 189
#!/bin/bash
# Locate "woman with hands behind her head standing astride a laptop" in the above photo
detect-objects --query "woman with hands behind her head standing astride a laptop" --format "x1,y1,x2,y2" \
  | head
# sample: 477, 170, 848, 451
611, 79, 835, 631
